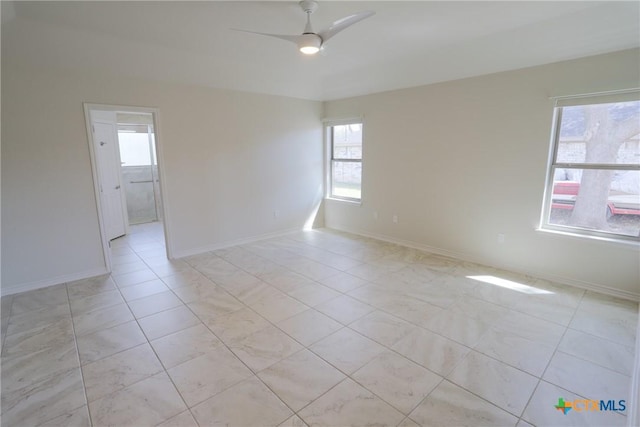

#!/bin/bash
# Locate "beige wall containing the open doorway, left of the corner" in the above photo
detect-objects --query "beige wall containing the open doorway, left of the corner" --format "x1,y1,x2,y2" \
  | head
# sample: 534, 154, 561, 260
1, 61, 322, 294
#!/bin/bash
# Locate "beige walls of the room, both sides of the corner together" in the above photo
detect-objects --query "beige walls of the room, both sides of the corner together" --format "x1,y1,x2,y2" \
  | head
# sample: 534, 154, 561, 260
1, 50, 640, 298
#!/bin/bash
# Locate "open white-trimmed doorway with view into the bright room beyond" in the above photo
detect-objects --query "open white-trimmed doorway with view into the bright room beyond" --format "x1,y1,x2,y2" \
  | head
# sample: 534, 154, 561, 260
85, 104, 170, 272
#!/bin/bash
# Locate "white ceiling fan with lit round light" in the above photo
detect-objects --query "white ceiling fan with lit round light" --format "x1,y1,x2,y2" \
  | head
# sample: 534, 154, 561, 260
236, 0, 375, 55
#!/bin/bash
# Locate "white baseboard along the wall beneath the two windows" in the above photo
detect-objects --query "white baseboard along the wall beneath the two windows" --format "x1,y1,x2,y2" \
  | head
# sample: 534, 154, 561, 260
327, 226, 640, 302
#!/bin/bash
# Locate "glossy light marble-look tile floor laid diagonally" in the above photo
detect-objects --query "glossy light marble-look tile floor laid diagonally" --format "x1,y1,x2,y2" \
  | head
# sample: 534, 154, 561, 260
1, 224, 638, 426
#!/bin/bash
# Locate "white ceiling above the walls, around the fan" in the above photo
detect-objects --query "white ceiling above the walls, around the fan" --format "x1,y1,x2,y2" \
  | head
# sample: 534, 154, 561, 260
2, 1, 640, 100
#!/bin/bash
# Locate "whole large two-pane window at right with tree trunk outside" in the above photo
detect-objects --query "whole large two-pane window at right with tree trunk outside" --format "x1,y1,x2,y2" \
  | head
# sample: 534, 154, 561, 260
541, 92, 640, 242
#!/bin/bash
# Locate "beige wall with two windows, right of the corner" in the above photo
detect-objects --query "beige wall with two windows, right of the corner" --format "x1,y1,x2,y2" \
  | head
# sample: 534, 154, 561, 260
325, 50, 640, 299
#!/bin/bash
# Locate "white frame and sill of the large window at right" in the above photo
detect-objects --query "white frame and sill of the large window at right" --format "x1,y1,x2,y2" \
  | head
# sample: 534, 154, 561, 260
538, 89, 640, 245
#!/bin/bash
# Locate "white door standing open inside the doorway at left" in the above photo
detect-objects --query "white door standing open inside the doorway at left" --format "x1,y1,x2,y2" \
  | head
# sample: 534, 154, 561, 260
93, 121, 127, 240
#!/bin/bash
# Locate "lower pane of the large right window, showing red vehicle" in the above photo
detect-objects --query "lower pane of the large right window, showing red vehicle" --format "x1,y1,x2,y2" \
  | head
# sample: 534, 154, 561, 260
549, 169, 640, 237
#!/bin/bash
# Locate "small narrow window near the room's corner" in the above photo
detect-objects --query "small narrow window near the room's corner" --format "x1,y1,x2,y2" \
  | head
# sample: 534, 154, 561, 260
327, 123, 362, 201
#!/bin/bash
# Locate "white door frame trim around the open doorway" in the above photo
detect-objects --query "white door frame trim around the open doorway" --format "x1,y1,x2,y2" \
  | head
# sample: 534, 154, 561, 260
83, 102, 174, 273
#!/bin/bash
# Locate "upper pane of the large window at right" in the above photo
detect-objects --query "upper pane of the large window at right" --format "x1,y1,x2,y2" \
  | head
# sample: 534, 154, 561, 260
556, 101, 640, 165
